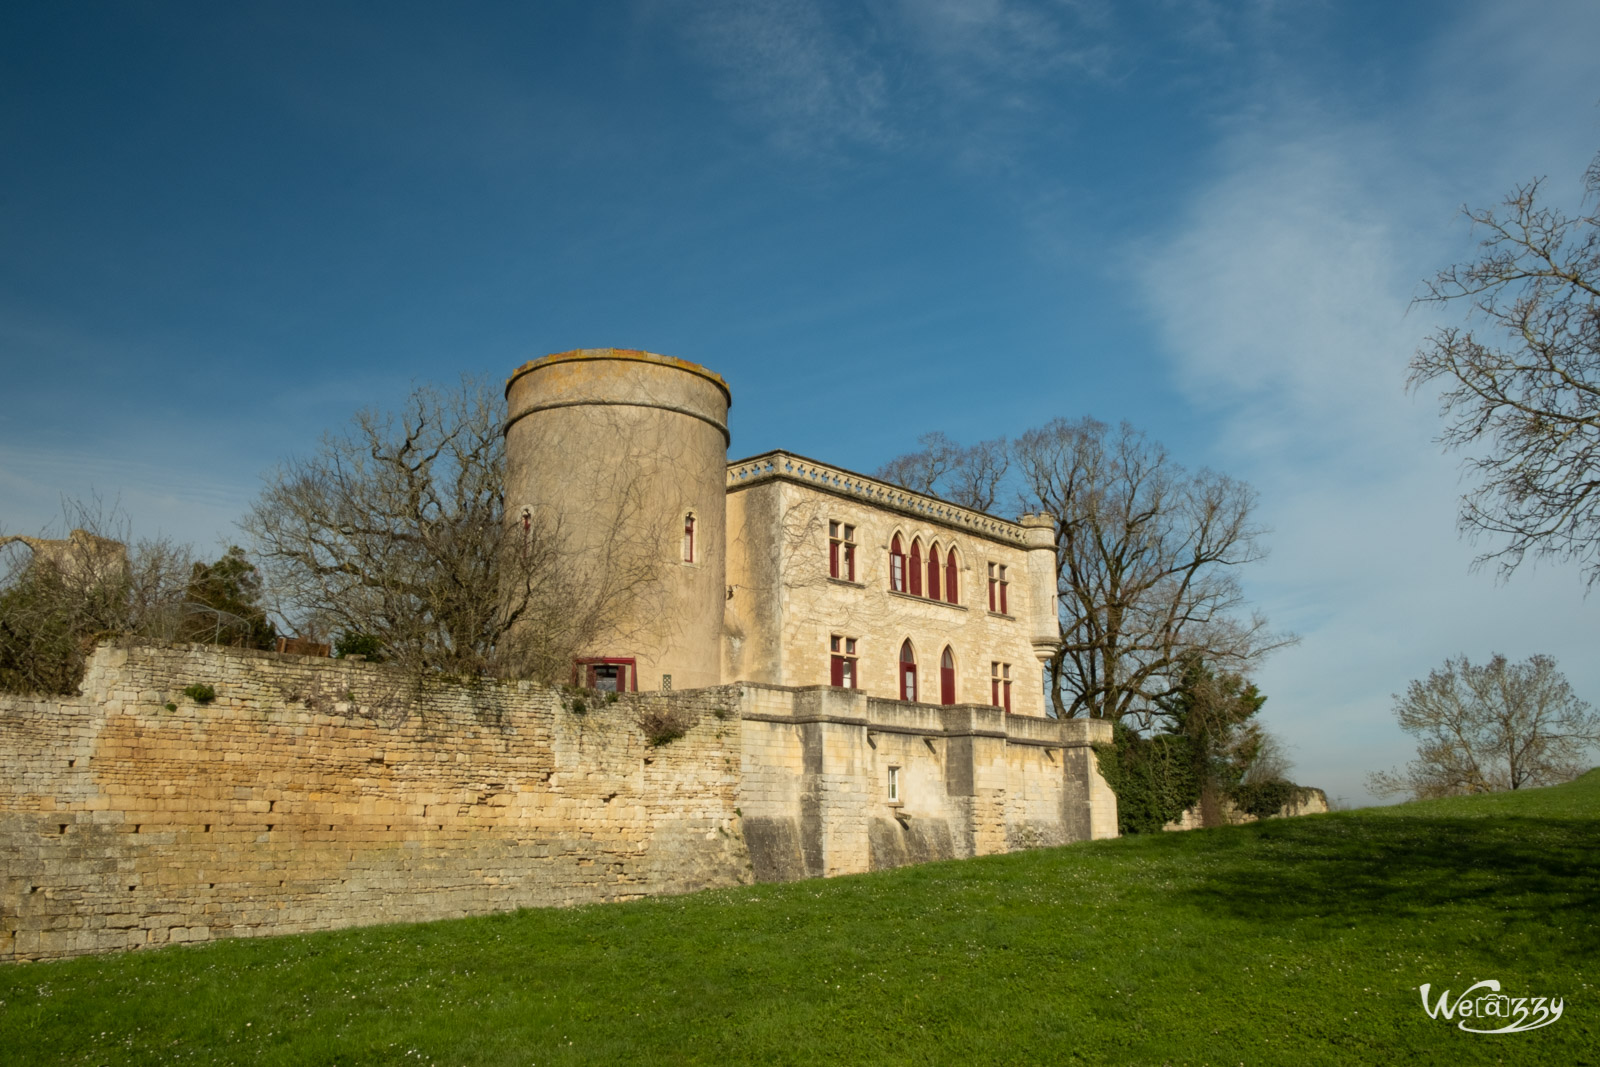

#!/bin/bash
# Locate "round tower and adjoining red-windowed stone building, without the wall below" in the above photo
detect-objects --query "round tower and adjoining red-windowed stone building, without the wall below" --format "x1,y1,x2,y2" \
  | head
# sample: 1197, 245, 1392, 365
506, 349, 1061, 715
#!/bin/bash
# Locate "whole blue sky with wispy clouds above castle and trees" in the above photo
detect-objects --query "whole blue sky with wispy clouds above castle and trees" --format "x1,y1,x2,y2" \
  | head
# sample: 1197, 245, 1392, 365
0, 0, 1600, 803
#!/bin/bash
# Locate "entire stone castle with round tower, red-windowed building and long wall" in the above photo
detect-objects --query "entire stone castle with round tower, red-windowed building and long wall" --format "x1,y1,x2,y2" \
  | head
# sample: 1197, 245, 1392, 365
0, 349, 1117, 960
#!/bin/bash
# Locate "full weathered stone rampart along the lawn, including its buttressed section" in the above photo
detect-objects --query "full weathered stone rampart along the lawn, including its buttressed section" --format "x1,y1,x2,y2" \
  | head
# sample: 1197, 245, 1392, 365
0, 645, 1115, 960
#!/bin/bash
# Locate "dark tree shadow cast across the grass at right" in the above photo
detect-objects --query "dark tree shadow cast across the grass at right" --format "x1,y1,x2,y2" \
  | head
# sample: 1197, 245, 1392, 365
1184, 816, 1600, 952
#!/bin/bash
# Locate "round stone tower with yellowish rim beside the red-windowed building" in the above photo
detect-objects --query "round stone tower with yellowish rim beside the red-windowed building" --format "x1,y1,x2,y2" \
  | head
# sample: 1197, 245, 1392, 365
506, 349, 733, 689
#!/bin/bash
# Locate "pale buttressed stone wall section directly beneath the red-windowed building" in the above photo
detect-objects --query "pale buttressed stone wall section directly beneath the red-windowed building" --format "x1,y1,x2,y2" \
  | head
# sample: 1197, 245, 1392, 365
739, 683, 1117, 881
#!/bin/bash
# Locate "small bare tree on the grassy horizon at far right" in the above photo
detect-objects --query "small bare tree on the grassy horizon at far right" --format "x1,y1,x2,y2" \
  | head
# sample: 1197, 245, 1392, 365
1366, 654, 1600, 800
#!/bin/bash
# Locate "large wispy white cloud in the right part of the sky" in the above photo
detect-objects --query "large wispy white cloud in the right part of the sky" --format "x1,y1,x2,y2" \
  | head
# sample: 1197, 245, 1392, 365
1138, 5, 1600, 800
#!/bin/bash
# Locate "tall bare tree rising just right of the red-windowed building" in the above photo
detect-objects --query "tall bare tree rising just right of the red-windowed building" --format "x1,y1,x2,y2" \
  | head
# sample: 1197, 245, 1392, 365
1013, 419, 1296, 716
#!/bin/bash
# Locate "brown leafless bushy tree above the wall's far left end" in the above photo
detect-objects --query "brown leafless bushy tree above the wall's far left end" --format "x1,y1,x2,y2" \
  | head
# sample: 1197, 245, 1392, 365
0, 501, 190, 693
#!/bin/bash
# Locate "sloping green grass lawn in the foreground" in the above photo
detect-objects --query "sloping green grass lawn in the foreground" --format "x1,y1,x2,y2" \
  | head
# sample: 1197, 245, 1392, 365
0, 771, 1600, 1067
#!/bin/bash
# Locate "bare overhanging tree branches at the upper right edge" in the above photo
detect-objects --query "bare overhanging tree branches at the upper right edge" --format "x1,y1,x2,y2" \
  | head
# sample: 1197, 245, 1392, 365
1410, 147, 1600, 587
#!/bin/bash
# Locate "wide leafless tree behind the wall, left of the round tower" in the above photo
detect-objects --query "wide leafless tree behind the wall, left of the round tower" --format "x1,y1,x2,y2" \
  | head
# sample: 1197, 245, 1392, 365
242, 381, 643, 678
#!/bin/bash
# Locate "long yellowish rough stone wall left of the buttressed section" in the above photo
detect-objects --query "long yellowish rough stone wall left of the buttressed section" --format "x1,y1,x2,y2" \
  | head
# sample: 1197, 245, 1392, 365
0, 646, 750, 958
